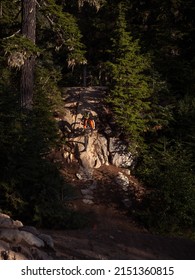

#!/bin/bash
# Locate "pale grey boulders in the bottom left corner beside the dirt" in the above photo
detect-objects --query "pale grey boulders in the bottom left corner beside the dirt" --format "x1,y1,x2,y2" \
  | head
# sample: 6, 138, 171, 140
0, 213, 54, 260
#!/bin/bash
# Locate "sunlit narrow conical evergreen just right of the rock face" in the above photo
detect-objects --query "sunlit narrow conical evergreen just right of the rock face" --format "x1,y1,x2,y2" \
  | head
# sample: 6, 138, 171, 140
107, 3, 152, 151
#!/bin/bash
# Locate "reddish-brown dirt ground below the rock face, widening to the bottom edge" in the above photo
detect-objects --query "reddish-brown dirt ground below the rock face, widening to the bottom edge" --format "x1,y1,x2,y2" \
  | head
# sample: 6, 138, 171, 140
43, 160, 195, 260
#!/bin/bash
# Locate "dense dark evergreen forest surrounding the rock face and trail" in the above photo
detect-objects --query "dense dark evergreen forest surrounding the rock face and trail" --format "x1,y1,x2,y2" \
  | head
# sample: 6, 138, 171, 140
0, 0, 195, 236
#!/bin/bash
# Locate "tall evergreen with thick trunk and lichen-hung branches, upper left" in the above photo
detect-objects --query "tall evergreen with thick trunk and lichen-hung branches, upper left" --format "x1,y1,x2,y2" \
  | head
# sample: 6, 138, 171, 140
1, 0, 86, 107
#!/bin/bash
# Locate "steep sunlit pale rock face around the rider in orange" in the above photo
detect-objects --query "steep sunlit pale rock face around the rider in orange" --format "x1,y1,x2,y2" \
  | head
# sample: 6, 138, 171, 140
56, 87, 133, 175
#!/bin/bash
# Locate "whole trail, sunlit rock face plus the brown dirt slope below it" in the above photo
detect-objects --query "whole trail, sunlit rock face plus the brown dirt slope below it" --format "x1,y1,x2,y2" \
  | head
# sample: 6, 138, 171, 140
44, 88, 195, 260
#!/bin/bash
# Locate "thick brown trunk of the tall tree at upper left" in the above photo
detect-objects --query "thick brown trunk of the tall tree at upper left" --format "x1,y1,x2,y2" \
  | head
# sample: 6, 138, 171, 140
20, 0, 36, 109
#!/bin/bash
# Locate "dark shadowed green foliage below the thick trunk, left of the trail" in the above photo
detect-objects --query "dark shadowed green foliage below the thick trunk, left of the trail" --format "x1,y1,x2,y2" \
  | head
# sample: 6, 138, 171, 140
0, 80, 86, 228
